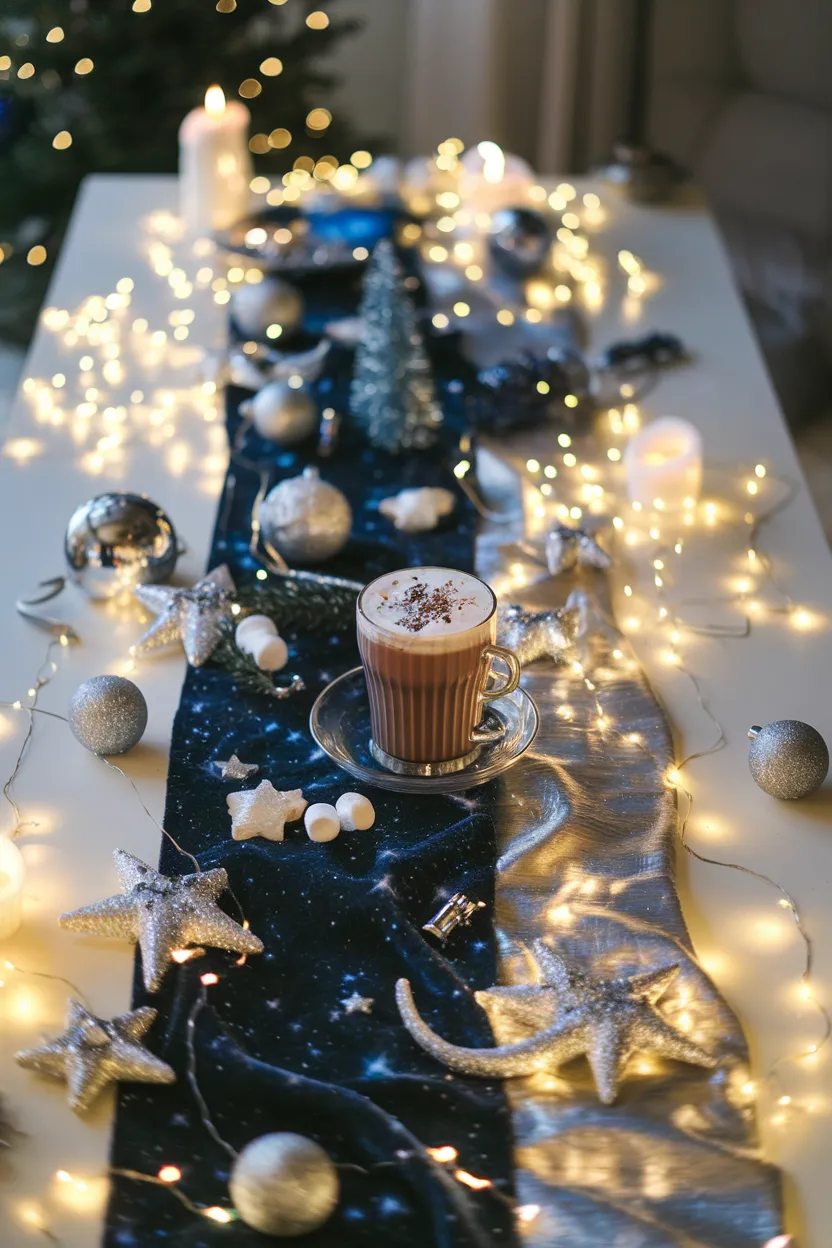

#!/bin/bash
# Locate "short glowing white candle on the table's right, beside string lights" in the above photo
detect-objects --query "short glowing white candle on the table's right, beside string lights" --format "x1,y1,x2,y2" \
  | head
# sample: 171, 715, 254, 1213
624, 416, 702, 510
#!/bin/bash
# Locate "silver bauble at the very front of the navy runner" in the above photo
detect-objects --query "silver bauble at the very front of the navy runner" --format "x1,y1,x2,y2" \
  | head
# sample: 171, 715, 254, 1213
228, 1131, 339, 1239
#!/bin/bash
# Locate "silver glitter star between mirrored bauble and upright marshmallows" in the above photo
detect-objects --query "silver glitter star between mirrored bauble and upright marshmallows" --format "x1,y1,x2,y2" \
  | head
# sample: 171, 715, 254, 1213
132, 563, 235, 668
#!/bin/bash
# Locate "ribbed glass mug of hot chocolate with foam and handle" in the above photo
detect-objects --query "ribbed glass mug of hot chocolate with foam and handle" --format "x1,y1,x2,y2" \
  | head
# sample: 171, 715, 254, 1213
357, 568, 520, 775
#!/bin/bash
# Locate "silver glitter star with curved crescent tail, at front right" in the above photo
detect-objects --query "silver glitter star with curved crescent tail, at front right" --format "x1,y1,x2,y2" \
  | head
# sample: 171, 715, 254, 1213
395, 941, 716, 1104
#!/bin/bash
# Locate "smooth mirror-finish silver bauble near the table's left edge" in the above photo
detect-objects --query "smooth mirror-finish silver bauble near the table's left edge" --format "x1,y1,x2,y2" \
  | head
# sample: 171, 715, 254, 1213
64, 494, 178, 598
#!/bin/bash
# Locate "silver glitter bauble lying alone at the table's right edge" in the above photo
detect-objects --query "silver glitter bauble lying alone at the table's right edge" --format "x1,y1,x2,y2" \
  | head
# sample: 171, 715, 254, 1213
748, 719, 830, 801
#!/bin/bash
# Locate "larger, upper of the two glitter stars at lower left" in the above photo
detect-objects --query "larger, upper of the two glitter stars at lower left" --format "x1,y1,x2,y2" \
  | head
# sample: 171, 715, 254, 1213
59, 850, 263, 992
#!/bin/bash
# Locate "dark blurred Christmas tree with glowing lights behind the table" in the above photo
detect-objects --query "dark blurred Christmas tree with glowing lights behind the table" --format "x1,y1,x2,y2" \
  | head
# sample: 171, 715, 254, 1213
0, 0, 358, 342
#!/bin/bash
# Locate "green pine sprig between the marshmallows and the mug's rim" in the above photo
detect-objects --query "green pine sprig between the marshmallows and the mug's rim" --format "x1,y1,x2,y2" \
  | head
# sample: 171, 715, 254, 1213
235, 573, 362, 633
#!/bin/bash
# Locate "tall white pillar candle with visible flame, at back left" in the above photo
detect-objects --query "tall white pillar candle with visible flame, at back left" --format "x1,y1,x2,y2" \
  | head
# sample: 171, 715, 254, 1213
180, 86, 252, 235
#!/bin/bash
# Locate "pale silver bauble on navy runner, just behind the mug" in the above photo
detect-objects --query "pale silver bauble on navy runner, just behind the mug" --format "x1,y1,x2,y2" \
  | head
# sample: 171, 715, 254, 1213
259, 468, 353, 564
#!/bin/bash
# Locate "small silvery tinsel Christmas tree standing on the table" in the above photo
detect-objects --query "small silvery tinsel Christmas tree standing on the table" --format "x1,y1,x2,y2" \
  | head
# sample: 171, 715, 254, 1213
349, 238, 443, 453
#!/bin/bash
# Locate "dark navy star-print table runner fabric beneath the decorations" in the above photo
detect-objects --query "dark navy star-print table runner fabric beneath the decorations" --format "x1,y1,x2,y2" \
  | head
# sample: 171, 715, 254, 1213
105, 309, 515, 1248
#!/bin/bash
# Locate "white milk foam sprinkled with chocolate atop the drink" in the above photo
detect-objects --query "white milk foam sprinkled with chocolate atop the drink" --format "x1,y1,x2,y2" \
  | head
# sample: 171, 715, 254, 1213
360, 568, 494, 650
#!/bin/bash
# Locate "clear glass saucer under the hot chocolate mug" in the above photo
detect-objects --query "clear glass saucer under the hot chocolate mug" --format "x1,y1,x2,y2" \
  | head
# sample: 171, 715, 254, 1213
309, 668, 540, 792
